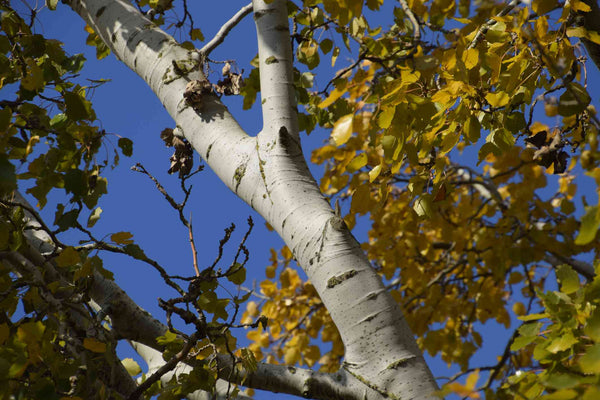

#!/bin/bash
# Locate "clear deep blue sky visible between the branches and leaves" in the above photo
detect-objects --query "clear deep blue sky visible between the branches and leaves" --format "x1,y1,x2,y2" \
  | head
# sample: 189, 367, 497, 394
12, 0, 600, 398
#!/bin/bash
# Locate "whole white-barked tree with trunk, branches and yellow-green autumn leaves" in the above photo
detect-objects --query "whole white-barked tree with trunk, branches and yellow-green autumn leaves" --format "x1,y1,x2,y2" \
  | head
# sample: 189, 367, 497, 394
0, 0, 600, 399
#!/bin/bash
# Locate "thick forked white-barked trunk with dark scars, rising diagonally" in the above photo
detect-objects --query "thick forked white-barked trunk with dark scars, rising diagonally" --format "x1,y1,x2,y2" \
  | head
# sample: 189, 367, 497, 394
67, 0, 436, 399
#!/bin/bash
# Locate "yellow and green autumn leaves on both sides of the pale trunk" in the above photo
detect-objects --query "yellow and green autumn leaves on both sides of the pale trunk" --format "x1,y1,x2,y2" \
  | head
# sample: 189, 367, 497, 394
0, 0, 600, 400
